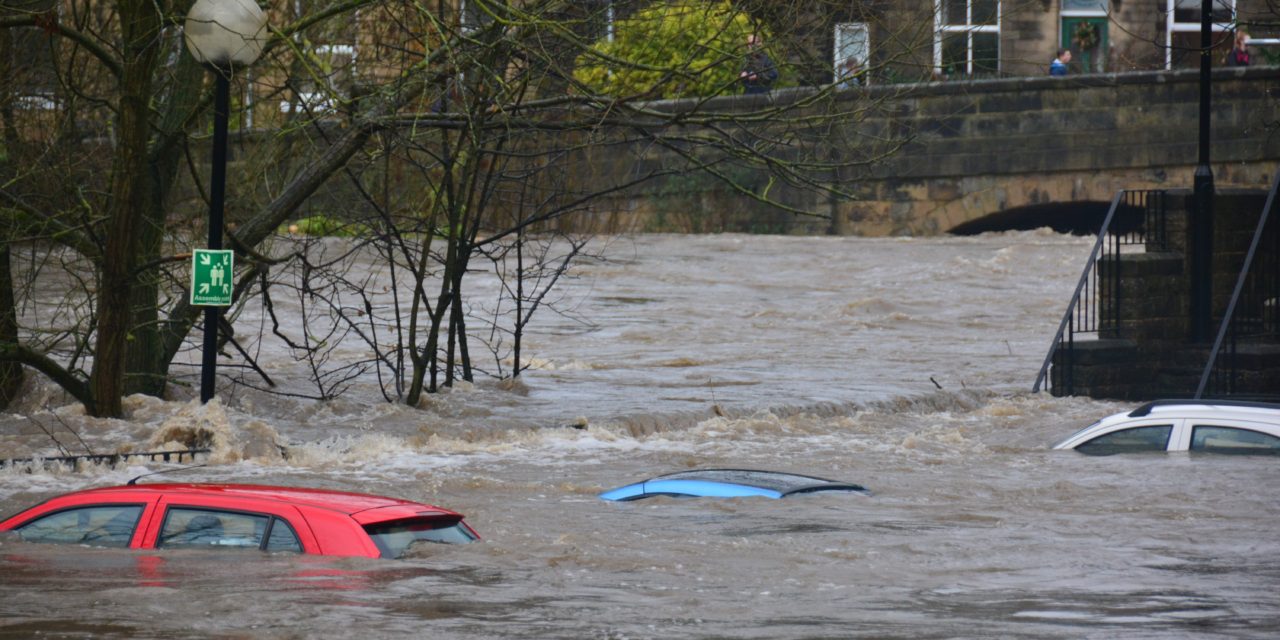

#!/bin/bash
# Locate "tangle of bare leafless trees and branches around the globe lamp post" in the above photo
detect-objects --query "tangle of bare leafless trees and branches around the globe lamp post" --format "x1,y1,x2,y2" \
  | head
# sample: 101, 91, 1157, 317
0, 0, 920, 416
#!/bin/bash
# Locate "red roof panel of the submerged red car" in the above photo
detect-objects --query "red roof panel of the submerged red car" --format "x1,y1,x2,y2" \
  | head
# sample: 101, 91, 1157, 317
66, 483, 453, 515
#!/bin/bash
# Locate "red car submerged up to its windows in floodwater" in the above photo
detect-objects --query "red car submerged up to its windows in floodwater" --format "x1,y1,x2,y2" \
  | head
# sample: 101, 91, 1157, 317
0, 484, 480, 558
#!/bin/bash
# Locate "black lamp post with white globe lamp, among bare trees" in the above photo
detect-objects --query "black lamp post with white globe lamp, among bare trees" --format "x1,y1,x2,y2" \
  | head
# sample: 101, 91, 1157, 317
183, 0, 266, 403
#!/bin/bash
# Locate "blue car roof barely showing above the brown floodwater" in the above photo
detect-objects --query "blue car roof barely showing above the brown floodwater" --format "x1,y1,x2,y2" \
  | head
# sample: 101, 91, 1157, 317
600, 468, 869, 500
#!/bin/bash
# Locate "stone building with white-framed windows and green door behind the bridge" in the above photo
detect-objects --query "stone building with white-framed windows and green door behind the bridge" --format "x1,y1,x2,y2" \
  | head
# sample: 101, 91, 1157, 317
808, 0, 1280, 81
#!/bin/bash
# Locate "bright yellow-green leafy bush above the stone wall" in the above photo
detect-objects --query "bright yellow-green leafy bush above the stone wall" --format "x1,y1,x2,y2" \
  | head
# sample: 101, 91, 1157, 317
573, 0, 777, 99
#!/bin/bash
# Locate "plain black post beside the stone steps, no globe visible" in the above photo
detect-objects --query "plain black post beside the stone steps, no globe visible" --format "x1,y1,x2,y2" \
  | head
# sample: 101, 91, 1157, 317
1190, 0, 1216, 342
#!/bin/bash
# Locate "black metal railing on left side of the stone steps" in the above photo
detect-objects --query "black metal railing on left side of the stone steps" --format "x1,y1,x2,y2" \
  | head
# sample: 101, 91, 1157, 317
1032, 189, 1169, 396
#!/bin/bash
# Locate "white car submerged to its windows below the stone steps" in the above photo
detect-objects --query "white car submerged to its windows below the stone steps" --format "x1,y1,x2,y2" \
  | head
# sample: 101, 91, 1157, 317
1053, 401, 1280, 456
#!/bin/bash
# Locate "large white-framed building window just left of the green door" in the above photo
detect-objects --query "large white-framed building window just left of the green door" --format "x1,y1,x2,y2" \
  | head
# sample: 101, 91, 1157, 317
933, 0, 1000, 76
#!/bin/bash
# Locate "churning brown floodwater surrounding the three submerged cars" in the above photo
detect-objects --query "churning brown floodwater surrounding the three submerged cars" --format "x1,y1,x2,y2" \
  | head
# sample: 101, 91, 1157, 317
0, 232, 1280, 639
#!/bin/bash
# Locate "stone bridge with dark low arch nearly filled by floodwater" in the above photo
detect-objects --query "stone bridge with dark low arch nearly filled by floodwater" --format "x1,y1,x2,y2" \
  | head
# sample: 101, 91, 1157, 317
598, 68, 1280, 236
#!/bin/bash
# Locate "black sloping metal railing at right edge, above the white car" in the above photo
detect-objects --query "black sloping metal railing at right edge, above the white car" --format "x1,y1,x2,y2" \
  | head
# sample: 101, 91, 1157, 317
1196, 172, 1280, 399
